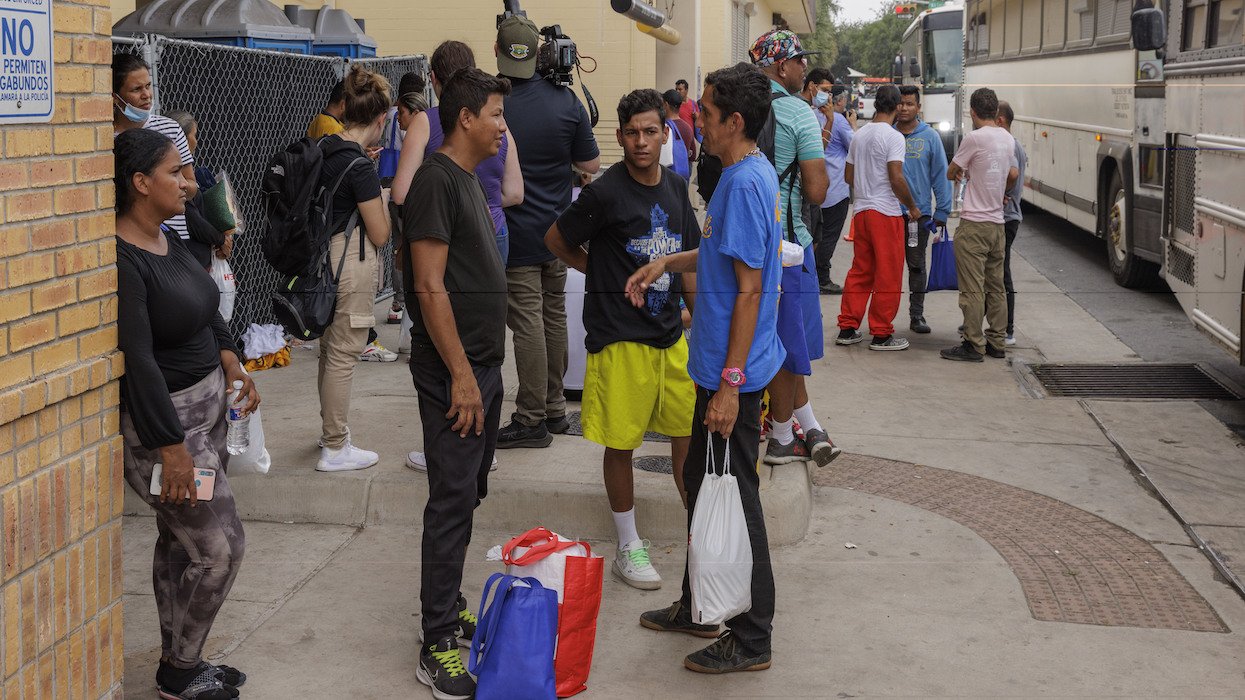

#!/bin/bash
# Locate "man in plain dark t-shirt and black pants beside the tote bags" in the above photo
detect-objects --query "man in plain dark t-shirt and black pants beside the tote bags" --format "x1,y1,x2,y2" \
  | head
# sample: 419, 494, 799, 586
402, 69, 510, 699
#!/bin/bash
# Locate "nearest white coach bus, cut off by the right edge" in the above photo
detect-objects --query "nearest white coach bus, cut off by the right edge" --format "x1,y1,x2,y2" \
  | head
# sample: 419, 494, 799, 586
1133, 0, 1245, 364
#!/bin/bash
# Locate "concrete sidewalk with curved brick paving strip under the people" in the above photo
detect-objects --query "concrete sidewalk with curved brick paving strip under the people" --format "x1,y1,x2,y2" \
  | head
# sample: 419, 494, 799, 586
125, 236, 1245, 699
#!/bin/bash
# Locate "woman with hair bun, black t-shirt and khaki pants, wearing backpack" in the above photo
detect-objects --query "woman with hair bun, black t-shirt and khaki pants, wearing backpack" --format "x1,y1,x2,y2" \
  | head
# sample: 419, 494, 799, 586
315, 66, 392, 472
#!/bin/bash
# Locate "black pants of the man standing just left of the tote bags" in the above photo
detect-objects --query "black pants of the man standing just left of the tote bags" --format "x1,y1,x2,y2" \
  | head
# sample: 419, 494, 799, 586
411, 362, 503, 644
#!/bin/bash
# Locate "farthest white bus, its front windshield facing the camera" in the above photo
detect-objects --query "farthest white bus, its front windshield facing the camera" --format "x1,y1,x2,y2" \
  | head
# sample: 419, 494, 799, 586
891, 2, 964, 158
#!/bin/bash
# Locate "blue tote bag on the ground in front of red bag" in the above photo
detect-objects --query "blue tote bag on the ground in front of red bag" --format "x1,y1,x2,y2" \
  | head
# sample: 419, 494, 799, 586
471, 573, 558, 700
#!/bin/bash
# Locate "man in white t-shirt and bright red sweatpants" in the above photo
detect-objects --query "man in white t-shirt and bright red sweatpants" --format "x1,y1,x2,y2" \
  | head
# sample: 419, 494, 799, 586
834, 85, 921, 350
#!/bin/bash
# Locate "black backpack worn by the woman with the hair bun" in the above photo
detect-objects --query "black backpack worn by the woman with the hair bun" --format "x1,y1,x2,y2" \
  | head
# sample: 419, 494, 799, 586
263, 138, 370, 340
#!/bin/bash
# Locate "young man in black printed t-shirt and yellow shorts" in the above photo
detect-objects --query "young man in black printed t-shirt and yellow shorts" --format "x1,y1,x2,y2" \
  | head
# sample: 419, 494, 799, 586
545, 90, 700, 590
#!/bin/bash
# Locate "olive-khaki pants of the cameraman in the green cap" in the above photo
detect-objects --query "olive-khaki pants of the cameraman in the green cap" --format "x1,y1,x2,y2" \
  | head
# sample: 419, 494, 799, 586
505, 260, 566, 427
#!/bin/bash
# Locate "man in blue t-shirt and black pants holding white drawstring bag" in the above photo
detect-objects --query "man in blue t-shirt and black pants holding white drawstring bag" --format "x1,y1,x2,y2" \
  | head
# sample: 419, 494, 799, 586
626, 64, 786, 674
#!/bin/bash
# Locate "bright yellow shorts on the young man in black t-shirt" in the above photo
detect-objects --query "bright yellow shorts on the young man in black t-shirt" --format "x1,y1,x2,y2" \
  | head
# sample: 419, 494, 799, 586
580, 335, 696, 450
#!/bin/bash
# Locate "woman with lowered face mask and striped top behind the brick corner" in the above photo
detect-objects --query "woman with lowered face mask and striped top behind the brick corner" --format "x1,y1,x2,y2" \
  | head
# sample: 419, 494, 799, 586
112, 54, 199, 240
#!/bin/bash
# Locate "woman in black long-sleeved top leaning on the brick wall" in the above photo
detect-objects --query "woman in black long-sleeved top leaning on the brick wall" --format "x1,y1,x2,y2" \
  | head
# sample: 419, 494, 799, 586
113, 130, 259, 700
